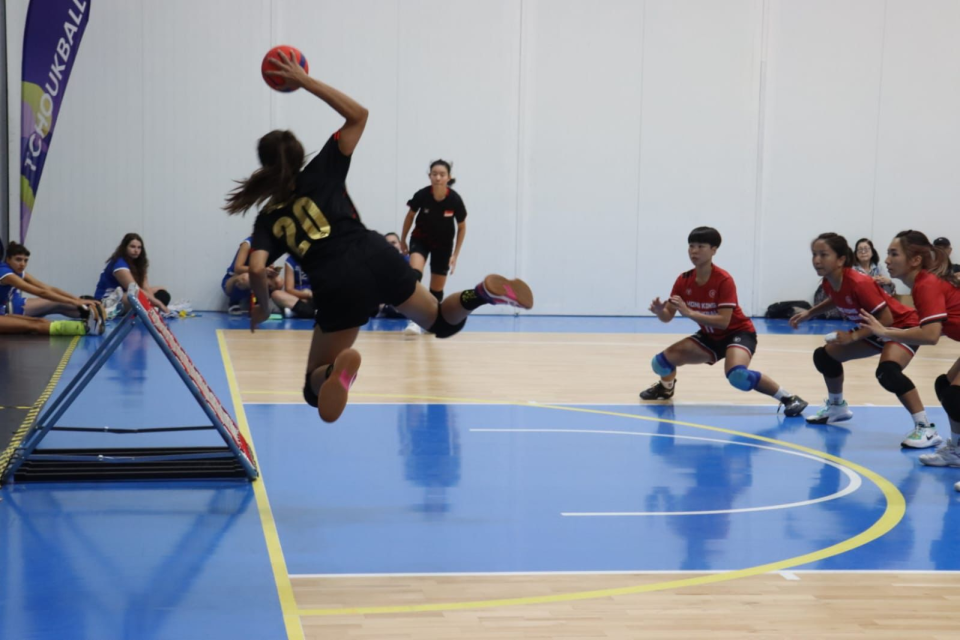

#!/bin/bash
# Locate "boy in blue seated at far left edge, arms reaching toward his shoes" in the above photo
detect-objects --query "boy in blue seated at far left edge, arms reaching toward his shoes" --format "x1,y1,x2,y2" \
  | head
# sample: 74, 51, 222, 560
0, 242, 103, 336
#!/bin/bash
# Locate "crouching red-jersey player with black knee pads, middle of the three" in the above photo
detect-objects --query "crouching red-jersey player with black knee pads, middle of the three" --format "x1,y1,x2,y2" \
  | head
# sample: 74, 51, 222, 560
790, 233, 941, 449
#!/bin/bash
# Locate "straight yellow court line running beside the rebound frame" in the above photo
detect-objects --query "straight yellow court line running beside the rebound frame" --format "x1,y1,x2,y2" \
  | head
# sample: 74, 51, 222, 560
217, 329, 304, 640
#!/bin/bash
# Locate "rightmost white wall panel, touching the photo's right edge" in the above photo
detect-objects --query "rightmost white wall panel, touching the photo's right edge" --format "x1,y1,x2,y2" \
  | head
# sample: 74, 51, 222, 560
873, 0, 960, 260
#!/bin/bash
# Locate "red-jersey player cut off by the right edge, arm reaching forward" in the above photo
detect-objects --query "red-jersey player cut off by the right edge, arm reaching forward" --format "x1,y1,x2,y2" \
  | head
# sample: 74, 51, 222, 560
860, 230, 960, 467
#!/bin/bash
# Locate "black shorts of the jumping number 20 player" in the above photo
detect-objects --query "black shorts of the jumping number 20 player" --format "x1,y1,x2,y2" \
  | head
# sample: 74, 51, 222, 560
307, 231, 417, 332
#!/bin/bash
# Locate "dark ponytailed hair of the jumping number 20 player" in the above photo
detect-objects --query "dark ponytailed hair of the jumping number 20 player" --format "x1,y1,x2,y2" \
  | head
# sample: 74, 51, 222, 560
223, 129, 304, 215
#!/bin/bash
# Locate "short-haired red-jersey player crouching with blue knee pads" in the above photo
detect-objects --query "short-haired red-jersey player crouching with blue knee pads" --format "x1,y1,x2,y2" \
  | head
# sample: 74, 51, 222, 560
640, 227, 807, 418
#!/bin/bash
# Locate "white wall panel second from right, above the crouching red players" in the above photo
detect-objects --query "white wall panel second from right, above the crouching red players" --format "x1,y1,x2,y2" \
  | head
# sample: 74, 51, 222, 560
756, 0, 886, 303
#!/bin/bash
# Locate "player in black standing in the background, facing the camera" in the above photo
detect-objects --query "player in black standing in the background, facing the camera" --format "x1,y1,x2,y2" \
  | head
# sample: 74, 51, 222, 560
400, 160, 467, 300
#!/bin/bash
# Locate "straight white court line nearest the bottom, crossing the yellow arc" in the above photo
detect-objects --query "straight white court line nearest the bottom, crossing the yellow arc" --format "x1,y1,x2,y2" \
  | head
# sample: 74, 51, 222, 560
290, 569, 960, 579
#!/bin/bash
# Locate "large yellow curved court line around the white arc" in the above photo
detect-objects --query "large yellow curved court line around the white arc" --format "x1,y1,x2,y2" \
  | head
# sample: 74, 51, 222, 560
288, 394, 906, 616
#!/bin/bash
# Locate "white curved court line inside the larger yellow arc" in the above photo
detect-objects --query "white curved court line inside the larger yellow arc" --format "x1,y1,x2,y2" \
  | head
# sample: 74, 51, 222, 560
470, 429, 863, 517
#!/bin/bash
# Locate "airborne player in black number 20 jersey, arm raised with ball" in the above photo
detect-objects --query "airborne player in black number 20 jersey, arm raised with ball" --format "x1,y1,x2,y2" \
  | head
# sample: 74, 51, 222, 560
224, 55, 533, 422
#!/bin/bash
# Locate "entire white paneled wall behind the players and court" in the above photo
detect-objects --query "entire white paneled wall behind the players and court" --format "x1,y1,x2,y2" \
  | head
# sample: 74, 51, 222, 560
7, 0, 960, 315
